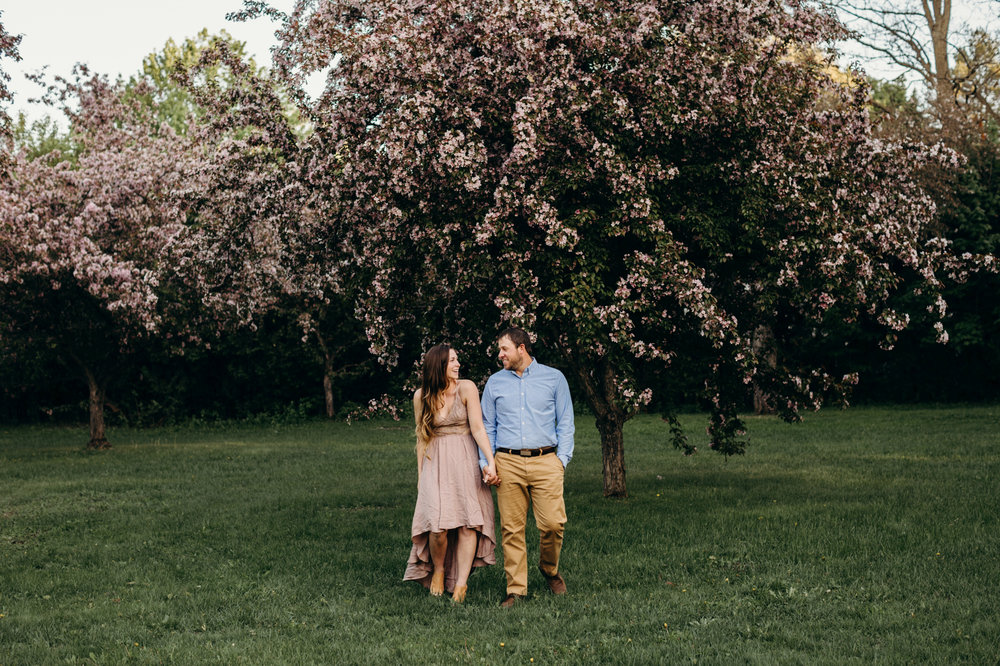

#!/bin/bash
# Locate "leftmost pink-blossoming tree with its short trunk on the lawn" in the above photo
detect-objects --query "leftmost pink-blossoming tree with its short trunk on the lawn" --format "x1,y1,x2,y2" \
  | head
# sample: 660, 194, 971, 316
0, 71, 211, 448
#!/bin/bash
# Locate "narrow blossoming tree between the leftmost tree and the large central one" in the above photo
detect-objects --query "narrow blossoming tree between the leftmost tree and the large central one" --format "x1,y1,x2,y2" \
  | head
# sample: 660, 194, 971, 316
180, 37, 378, 418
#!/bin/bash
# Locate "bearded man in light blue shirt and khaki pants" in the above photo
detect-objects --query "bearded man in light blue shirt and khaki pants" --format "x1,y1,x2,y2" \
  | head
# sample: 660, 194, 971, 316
479, 328, 575, 608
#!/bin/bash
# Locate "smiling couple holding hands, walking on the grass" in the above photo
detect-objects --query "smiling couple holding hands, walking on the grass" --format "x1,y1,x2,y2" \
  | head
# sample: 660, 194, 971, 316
403, 328, 574, 608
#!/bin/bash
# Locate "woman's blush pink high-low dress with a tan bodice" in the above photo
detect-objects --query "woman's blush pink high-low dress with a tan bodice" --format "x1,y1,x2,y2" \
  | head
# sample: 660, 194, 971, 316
403, 396, 496, 592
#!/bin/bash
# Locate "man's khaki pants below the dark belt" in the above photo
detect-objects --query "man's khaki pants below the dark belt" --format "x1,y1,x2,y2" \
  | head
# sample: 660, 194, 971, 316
496, 453, 566, 596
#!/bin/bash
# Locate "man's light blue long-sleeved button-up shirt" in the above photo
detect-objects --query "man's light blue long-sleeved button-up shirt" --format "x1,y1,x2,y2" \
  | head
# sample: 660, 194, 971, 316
479, 360, 576, 467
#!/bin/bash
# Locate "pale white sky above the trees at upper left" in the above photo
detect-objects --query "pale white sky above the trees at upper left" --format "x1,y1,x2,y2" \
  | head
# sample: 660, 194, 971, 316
0, 0, 294, 118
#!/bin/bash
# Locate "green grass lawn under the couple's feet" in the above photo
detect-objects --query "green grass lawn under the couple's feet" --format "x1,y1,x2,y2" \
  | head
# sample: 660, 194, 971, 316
0, 407, 1000, 666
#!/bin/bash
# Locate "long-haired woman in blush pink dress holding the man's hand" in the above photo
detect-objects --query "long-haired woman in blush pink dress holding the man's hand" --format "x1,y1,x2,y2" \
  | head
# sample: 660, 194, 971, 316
403, 344, 499, 603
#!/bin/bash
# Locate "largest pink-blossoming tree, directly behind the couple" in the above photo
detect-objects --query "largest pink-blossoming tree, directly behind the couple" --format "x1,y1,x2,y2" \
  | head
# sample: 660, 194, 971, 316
254, 0, 988, 496
